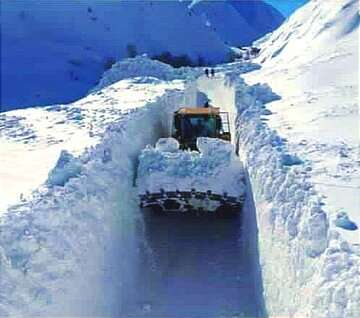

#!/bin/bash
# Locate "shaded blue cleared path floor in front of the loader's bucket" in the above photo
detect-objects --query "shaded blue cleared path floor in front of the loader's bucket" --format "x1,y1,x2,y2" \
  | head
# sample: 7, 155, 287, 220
121, 197, 262, 318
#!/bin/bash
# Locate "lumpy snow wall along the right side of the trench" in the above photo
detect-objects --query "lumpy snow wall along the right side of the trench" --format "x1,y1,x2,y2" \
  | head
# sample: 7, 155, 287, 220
225, 73, 360, 317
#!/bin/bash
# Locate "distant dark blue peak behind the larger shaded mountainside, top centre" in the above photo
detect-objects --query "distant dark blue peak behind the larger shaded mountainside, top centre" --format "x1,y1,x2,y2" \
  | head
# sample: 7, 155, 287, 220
190, 0, 284, 46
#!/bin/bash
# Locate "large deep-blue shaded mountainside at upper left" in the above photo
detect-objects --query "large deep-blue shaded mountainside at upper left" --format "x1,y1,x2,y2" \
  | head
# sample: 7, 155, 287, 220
1, 0, 228, 111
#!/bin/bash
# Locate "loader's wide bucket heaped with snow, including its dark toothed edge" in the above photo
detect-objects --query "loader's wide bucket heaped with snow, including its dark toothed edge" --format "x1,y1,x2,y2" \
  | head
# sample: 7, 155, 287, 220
137, 137, 245, 215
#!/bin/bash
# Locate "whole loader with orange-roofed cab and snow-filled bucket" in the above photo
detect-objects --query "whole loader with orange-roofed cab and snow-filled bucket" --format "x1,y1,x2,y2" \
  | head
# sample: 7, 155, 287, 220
137, 106, 245, 215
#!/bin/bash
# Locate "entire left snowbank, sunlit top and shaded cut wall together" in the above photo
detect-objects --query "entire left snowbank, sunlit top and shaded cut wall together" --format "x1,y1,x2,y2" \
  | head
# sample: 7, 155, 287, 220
0, 58, 187, 317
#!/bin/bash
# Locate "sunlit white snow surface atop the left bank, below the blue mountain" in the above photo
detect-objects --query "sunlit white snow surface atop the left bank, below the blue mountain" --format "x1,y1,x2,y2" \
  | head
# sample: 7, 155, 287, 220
0, 64, 182, 213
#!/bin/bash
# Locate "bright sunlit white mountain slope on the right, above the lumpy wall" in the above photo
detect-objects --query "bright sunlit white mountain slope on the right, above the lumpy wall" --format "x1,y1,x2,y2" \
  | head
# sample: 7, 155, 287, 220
245, 0, 360, 244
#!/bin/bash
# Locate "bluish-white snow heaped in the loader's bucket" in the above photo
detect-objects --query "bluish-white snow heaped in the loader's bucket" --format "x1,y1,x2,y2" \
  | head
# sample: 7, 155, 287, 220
137, 137, 245, 210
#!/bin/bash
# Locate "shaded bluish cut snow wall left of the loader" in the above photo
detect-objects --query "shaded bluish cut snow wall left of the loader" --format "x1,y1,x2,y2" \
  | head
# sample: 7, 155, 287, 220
0, 90, 184, 317
